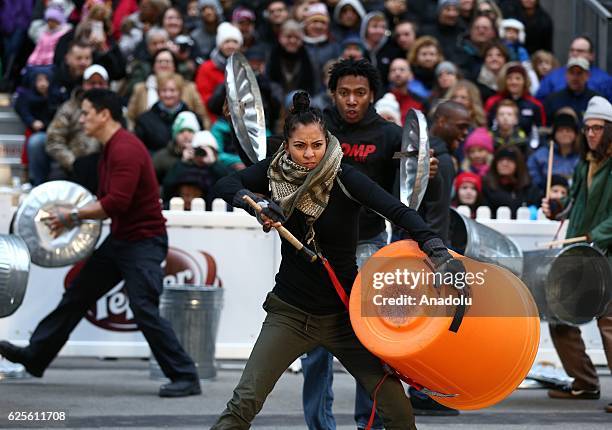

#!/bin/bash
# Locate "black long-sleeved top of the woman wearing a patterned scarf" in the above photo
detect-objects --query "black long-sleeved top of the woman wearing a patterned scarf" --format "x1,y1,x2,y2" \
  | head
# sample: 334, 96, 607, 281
213, 158, 436, 315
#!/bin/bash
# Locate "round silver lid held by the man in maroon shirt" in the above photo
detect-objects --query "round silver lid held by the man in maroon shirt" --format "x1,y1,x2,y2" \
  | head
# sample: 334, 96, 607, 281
13, 181, 102, 267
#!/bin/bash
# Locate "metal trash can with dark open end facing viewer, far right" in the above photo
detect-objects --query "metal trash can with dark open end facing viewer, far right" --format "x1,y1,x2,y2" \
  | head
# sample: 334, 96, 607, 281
523, 243, 612, 325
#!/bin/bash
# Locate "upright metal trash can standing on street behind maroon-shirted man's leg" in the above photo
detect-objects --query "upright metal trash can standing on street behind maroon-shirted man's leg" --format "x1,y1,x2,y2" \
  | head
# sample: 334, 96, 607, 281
149, 285, 223, 379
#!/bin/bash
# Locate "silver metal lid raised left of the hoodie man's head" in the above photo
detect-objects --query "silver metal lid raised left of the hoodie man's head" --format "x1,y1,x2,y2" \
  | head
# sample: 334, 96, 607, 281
225, 52, 266, 163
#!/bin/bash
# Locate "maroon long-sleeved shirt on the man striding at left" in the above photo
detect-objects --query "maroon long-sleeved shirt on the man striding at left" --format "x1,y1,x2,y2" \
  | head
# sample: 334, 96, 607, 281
98, 128, 166, 242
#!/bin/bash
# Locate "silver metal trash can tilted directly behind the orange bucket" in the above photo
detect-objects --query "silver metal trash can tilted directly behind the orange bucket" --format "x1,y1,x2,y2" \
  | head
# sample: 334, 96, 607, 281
449, 208, 523, 277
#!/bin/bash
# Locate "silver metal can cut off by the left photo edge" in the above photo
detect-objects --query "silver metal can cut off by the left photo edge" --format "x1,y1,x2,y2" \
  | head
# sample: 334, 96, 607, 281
0, 234, 30, 318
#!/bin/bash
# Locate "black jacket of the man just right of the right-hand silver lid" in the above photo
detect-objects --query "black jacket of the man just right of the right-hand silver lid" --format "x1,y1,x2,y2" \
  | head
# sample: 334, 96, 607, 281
419, 136, 456, 245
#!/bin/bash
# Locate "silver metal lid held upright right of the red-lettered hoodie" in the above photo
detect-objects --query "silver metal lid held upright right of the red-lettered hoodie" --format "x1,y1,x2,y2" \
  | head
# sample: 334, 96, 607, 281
400, 109, 429, 210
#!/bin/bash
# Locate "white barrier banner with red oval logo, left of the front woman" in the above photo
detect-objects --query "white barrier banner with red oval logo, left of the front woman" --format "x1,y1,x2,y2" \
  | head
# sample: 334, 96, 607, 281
0, 223, 280, 358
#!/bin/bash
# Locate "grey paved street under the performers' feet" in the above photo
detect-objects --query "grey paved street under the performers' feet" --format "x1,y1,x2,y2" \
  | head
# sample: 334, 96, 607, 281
0, 358, 612, 430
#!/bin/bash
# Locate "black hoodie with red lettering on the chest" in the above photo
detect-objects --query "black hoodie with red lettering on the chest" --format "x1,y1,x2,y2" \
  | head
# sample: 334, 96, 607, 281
324, 105, 402, 240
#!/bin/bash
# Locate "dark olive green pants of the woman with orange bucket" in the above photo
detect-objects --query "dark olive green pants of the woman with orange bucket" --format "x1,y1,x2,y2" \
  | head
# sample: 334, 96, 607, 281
212, 293, 416, 430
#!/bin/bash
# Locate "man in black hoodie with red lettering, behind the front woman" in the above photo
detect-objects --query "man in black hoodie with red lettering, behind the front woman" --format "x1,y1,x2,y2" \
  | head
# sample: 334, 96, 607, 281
302, 59, 402, 429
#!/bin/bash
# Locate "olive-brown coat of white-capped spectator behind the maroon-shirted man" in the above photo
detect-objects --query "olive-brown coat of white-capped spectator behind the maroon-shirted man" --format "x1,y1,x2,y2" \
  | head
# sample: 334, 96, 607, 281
46, 88, 101, 172
